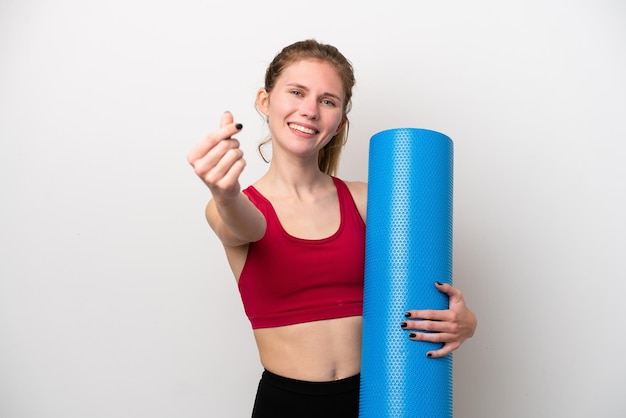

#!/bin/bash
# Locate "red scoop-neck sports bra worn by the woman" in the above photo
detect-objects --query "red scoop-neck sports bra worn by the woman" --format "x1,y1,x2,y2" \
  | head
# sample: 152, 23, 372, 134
239, 177, 365, 329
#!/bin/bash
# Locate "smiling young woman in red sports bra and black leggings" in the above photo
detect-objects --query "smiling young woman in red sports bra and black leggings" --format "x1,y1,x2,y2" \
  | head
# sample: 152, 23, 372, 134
188, 40, 476, 418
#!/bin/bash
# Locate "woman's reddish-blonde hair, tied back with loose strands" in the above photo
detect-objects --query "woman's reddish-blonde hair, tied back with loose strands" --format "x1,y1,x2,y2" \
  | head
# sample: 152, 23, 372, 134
258, 39, 355, 175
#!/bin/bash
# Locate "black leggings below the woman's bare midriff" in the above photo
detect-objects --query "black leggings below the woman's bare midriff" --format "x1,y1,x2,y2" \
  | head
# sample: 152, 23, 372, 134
252, 370, 361, 418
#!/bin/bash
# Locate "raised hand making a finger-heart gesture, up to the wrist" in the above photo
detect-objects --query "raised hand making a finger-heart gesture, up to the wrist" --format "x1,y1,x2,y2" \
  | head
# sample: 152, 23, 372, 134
187, 112, 246, 201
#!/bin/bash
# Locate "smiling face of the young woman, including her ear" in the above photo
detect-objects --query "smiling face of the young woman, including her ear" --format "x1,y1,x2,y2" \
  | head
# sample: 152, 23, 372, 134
257, 59, 345, 162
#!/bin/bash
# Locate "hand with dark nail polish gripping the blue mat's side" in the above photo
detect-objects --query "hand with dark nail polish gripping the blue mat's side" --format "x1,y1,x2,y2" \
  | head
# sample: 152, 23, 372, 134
401, 283, 477, 358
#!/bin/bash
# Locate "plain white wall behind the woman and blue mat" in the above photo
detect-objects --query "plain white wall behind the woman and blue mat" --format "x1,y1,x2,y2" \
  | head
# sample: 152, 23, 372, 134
0, 0, 626, 418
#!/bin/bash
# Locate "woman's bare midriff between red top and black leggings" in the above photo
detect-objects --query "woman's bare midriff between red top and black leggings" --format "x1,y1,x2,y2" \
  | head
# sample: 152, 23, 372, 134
254, 316, 362, 382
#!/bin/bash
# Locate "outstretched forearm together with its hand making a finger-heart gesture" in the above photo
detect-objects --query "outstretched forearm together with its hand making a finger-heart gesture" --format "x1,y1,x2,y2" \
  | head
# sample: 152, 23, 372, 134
187, 112, 266, 247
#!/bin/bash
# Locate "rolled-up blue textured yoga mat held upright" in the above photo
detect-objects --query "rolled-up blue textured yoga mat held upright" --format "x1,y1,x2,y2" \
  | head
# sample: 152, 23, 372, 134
359, 128, 453, 418
